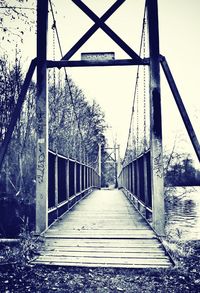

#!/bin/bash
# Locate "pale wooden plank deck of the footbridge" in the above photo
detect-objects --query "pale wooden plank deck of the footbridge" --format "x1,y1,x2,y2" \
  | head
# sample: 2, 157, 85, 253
34, 190, 171, 268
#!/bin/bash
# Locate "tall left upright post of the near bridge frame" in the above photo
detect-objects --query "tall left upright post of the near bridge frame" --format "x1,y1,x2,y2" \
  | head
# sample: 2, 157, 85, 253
36, 0, 48, 233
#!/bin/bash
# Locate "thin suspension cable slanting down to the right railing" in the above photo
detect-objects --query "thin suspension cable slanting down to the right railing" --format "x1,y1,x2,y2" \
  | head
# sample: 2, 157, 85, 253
122, 3, 146, 163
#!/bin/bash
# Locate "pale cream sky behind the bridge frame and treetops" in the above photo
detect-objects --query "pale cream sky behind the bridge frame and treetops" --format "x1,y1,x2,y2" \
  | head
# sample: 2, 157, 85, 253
1, 0, 200, 164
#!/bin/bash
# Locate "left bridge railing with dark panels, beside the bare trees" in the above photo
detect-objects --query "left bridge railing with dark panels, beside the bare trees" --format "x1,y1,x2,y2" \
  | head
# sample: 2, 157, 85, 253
48, 150, 100, 225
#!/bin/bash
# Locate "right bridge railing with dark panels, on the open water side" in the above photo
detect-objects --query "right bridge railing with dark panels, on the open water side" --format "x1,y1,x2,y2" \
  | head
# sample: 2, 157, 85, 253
118, 150, 152, 222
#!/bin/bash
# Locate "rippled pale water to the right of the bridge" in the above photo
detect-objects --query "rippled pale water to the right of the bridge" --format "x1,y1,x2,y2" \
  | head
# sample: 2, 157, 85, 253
166, 187, 200, 240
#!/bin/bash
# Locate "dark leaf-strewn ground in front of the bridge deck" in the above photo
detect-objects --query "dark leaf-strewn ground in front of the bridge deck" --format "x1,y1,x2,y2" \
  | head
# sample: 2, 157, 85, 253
0, 241, 200, 293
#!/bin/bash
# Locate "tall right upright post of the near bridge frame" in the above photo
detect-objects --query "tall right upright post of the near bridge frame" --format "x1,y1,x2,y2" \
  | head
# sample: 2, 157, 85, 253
146, 0, 165, 236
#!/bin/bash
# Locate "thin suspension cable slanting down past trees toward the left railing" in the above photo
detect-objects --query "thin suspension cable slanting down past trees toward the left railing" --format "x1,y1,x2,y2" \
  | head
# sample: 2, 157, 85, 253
49, 0, 86, 152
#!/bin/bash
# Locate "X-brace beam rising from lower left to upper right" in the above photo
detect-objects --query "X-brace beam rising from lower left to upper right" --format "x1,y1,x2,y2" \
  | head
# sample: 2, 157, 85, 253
61, 0, 125, 60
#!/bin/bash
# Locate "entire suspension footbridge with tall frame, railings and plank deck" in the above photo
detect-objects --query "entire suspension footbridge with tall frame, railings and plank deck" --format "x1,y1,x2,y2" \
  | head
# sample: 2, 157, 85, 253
0, 0, 200, 268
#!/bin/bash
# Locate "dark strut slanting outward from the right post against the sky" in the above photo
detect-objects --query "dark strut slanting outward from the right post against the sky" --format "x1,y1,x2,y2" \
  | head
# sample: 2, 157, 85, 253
160, 56, 200, 161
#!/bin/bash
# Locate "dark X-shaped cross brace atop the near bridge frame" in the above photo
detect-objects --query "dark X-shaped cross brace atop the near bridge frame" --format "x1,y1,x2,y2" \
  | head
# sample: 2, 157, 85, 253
62, 0, 142, 62
